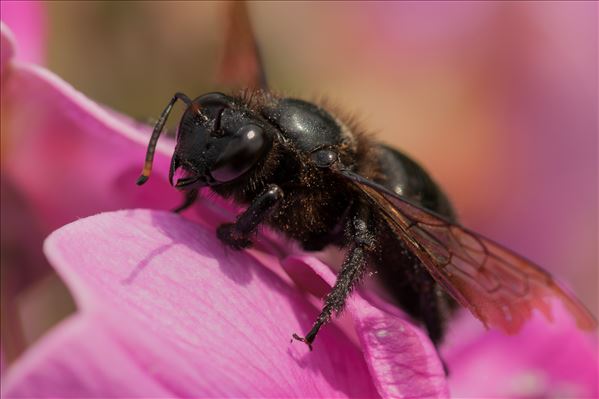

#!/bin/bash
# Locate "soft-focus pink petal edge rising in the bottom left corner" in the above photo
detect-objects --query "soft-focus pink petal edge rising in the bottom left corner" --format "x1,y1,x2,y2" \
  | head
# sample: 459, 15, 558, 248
2, 315, 174, 398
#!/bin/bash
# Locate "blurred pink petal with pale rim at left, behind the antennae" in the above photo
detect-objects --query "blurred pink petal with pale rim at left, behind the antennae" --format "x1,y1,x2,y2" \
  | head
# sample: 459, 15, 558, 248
2, 26, 181, 232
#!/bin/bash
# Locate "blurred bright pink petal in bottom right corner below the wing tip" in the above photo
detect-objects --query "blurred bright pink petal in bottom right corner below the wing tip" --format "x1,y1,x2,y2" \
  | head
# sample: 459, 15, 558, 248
444, 303, 599, 398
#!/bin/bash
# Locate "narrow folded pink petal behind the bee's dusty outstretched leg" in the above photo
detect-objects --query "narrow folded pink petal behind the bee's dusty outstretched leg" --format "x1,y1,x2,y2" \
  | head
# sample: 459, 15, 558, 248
284, 256, 449, 398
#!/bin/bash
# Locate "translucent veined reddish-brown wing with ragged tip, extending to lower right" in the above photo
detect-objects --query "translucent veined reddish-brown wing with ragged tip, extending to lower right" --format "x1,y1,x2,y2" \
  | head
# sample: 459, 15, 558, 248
340, 170, 597, 334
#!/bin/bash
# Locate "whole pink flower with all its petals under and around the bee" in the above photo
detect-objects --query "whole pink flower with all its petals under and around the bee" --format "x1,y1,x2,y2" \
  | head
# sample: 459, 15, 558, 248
2, 6, 599, 397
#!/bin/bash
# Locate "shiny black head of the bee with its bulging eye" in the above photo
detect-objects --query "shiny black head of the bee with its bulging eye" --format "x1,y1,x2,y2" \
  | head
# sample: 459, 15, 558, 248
170, 93, 272, 190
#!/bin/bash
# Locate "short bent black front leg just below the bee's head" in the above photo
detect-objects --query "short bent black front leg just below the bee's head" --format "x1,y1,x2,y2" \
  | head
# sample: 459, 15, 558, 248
216, 184, 283, 249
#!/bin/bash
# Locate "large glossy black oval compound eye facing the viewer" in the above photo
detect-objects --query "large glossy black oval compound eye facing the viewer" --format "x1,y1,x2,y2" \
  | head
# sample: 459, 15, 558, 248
211, 124, 266, 183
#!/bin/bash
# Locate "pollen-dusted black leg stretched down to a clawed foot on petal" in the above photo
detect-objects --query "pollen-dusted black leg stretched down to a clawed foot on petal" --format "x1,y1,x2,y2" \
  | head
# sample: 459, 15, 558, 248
293, 211, 375, 350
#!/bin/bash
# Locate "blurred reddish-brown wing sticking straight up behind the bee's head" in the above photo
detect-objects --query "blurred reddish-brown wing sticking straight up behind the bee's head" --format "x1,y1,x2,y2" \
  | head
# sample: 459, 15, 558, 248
219, 1, 266, 89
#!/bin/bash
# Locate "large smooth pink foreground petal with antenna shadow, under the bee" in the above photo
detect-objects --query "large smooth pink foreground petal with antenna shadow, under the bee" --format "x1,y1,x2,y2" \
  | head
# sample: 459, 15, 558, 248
3, 210, 377, 397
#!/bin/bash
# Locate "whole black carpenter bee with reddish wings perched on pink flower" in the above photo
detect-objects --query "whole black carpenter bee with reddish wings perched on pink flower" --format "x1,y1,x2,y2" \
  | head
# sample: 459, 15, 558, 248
137, 2, 596, 354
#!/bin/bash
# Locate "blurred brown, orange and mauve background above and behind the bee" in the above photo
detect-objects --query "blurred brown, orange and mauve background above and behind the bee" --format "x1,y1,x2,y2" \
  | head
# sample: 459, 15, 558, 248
2, 2, 598, 366
